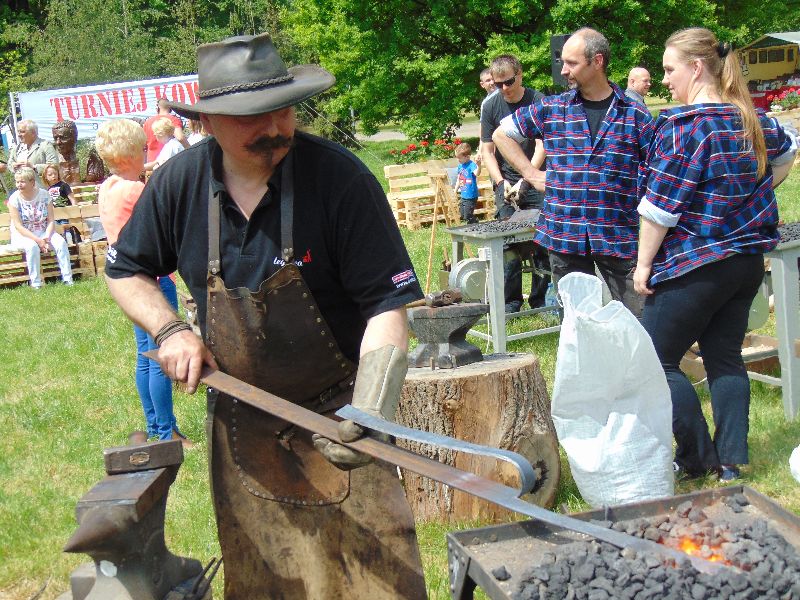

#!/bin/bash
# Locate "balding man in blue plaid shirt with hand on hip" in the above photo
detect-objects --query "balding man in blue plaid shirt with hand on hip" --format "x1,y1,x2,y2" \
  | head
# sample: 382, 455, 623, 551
493, 28, 653, 316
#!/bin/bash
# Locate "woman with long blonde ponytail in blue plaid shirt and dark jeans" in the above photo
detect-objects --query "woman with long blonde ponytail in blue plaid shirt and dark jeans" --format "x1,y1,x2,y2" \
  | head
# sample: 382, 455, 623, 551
634, 28, 796, 481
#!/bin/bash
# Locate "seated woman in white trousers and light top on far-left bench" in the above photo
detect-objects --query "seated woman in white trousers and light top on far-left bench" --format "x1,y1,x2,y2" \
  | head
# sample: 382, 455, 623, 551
8, 167, 72, 289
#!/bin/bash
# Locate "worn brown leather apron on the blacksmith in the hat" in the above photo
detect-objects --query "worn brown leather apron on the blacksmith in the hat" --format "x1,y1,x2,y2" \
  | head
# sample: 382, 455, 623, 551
206, 151, 426, 600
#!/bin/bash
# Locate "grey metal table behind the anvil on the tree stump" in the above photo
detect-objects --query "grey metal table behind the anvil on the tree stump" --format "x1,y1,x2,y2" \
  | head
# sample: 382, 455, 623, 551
445, 220, 561, 354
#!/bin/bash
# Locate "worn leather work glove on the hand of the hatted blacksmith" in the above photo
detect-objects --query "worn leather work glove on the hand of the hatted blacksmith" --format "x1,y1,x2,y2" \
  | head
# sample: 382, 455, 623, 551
312, 345, 408, 471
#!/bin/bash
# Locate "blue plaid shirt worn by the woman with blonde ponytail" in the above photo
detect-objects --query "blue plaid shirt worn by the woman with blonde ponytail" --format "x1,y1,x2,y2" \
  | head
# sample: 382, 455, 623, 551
639, 104, 792, 285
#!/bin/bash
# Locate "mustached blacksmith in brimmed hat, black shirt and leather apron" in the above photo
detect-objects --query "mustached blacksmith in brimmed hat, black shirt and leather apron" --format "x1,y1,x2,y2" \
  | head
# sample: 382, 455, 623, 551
106, 34, 426, 600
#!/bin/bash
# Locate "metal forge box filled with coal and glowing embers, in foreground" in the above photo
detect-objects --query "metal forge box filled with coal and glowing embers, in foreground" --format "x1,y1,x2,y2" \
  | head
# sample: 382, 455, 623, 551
447, 486, 800, 600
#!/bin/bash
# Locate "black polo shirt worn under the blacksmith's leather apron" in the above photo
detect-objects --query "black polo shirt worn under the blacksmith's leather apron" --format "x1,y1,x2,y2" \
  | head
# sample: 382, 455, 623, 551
106, 132, 422, 361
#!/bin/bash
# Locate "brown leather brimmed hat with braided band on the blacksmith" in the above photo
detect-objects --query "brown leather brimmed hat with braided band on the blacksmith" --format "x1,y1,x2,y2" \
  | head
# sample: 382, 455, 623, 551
167, 33, 336, 119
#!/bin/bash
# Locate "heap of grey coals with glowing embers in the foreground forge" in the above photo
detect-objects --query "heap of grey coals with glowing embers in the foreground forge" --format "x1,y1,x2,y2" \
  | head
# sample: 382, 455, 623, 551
514, 493, 800, 600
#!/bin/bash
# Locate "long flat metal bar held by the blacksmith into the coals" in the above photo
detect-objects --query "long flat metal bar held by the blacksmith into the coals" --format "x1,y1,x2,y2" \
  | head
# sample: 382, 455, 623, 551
159, 351, 728, 573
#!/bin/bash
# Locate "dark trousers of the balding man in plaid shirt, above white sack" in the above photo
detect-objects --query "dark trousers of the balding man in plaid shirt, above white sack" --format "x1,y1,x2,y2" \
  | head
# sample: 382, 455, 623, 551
550, 250, 644, 318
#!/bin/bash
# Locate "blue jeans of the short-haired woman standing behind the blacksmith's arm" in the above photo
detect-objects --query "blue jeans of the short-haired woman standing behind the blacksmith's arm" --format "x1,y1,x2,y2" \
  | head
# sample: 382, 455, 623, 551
133, 277, 178, 440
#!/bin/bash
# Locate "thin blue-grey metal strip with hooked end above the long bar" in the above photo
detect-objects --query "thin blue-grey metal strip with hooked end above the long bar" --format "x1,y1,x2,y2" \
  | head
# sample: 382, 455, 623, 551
336, 404, 536, 496
